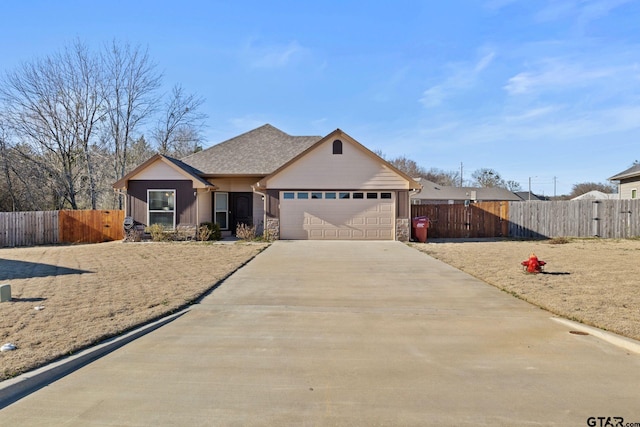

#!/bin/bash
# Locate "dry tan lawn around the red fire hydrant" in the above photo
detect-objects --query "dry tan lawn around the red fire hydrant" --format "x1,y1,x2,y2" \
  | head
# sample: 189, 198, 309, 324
414, 239, 640, 340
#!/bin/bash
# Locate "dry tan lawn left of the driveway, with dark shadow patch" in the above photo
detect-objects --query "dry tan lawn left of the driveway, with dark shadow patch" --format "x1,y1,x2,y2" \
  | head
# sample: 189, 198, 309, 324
0, 242, 266, 381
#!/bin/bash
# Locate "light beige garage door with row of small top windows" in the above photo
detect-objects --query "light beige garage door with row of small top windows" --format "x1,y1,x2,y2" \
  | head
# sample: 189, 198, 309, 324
280, 191, 395, 240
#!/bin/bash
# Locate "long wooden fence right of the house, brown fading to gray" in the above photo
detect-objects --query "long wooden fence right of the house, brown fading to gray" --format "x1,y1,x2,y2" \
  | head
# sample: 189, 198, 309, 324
411, 200, 640, 239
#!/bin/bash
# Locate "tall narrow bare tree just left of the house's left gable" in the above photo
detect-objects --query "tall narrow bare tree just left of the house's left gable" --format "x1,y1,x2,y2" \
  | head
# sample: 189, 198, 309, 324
102, 41, 162, 209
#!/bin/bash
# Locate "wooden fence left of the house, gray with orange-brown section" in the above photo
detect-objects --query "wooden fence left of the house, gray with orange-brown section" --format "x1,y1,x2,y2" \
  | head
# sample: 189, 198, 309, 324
0, 210, 124, 247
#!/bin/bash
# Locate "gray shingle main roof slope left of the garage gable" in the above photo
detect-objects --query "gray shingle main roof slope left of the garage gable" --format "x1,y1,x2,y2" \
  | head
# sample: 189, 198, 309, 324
181, 124, 322, 176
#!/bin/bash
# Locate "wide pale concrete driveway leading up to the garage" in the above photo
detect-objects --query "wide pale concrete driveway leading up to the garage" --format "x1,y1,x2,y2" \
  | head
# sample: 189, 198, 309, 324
0, 241, 640, 426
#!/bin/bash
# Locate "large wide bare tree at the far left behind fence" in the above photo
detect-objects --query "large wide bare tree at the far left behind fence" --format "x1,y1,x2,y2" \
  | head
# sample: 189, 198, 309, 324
0, 42, 101, 209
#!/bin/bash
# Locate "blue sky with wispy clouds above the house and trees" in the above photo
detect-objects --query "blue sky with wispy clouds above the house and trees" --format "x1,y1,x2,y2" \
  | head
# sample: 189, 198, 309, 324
0, 0, 640, 195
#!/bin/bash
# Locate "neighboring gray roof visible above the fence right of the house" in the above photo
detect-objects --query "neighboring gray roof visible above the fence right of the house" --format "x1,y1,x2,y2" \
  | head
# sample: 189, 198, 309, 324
411, 178, 522, 201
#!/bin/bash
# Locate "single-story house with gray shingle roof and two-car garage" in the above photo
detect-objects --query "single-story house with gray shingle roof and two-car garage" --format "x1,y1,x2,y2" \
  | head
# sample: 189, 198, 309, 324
113, 124, 421, 241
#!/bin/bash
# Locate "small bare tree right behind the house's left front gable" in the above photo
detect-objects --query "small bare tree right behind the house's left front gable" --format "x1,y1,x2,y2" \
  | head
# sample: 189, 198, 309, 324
152, 85, 207, 158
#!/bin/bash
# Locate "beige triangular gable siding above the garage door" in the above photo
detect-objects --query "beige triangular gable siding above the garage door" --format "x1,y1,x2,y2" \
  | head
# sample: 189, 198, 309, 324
266, 138, 409, 190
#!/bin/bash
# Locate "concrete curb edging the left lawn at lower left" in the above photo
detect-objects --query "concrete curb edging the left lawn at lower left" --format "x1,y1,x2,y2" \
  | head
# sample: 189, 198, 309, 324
0, 308, 191, 409
